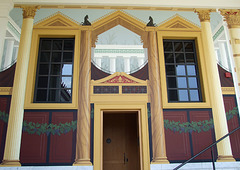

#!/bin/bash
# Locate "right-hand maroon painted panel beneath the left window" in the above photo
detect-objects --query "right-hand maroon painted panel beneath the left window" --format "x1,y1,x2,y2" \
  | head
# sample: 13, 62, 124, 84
49, 112, 76, 163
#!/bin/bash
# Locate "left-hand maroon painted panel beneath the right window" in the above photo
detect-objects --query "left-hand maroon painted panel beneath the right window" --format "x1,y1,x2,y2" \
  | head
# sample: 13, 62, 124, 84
164, 111, 191, 161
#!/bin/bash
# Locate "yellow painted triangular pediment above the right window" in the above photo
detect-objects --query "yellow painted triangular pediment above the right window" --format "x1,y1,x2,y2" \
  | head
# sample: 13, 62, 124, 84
158, 15, 201, 31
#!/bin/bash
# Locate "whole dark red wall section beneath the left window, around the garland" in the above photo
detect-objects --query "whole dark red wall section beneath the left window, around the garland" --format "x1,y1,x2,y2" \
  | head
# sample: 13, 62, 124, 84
20, 110, 77, 165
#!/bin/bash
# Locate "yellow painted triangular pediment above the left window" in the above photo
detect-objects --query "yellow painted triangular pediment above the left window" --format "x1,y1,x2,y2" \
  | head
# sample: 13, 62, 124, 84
34, 12, 80, 29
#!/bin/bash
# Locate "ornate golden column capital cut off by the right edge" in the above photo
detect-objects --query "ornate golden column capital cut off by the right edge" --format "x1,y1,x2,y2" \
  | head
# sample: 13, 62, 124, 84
219, 9, 240, 28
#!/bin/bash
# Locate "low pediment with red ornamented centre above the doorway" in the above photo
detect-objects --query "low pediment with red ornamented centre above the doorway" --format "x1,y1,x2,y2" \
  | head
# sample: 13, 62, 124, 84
92, 72, 146, 84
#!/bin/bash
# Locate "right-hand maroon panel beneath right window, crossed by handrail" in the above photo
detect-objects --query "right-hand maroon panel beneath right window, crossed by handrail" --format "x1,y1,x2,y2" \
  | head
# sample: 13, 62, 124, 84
189, 111, 214, 160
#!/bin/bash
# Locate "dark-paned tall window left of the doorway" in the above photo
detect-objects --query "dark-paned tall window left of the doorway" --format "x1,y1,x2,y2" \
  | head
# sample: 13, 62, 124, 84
34, 38, 74, 103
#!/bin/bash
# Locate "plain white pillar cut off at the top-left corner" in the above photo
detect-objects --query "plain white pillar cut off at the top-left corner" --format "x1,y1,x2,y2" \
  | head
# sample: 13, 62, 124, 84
0, 0, 14, 66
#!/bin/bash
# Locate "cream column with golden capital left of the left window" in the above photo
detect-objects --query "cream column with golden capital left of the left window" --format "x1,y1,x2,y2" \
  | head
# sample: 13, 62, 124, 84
2, 6, 37, 166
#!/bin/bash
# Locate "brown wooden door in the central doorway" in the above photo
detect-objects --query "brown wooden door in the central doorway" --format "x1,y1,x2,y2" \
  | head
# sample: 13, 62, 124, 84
103, 113, 140, 170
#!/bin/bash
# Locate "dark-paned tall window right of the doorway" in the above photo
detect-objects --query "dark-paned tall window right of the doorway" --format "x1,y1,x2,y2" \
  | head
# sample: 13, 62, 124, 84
163, 40, 202, 102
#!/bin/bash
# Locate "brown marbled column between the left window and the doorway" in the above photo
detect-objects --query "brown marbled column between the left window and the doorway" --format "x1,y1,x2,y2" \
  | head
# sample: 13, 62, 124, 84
73, 26, 92, 166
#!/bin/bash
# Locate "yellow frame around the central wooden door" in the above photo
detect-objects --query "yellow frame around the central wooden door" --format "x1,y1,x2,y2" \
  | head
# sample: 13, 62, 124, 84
93, 102, 150, 170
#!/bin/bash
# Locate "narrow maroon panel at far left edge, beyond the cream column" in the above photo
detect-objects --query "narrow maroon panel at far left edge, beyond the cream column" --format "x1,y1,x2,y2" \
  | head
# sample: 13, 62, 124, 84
0, 96, 11, 163
